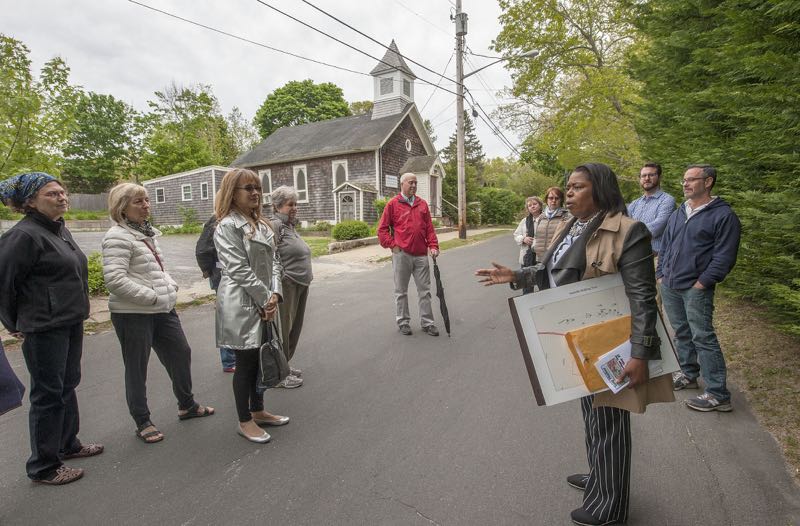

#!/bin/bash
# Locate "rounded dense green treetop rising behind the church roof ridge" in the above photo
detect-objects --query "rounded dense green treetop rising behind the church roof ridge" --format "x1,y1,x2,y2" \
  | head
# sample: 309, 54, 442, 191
253, 79, 350, 139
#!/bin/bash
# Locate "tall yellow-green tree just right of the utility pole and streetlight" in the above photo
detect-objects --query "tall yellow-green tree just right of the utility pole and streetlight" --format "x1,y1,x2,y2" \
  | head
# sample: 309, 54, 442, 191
494, 0, 640, 176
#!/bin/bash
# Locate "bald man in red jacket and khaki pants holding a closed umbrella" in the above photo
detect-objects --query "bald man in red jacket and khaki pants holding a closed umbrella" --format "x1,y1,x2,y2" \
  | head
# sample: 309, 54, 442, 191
378, 173, 439, 336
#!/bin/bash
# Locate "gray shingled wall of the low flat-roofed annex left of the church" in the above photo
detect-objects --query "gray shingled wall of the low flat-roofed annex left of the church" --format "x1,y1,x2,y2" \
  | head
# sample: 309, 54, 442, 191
142, 170, 220, 225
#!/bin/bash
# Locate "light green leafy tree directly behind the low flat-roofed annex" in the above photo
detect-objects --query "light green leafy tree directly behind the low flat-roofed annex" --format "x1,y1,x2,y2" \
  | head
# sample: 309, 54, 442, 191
138, 84, 238, 179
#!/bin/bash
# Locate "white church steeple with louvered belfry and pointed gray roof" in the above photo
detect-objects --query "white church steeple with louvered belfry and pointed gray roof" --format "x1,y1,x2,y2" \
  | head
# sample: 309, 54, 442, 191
370, 40, 417, 119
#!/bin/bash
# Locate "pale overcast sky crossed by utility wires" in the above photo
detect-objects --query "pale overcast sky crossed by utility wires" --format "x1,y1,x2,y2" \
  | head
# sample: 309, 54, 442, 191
0, 0, 518, 157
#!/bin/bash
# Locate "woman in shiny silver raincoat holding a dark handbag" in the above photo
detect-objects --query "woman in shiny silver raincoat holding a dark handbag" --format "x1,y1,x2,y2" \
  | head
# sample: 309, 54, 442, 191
214, 168, 289, 443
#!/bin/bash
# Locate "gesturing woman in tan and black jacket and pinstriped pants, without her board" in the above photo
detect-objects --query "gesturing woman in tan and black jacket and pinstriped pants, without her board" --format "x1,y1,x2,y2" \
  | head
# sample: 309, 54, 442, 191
476, 163, 674, 525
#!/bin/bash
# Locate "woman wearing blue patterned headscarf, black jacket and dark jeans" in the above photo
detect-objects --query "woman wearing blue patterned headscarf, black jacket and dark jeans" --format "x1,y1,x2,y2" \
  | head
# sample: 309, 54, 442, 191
0, 172, 103, 485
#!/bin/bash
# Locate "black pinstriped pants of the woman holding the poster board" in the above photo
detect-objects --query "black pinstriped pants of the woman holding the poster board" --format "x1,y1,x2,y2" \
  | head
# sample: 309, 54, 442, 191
581, 395, 632, 522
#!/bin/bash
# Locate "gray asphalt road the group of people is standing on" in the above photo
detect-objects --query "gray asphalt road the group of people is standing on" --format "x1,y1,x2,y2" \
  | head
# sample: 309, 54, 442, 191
0, 238, 800, 526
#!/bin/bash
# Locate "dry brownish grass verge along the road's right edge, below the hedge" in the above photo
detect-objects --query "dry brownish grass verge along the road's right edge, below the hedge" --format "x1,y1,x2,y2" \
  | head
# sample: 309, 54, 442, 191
714, 291, 800, 482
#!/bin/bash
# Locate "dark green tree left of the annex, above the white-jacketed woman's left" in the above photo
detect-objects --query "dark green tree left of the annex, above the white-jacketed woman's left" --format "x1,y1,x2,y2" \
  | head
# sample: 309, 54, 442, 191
63, 92, 136, 193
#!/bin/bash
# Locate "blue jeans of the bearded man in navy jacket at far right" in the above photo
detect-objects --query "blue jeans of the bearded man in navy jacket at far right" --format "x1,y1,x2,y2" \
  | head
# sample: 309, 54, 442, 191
660, 283, 731, 400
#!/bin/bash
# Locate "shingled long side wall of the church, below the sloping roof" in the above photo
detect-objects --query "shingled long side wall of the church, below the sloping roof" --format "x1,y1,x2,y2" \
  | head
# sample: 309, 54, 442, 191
253, 152, 375, 227
